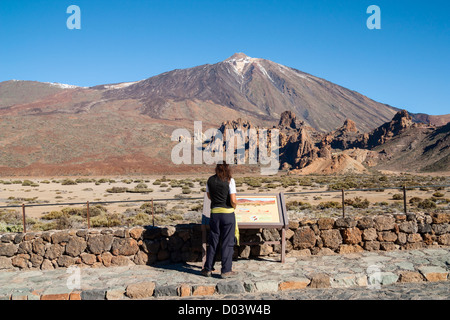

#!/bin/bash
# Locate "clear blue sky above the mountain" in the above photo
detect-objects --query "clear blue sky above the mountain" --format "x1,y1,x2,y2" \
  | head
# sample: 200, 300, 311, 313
0, 0, 450, 114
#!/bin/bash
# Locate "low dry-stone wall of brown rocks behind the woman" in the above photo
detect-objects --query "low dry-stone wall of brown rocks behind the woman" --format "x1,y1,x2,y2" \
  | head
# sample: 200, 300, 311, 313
0, 213, 450, 270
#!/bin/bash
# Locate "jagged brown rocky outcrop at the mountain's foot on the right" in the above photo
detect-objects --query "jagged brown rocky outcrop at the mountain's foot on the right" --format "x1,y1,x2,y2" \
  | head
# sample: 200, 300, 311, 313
212, 110, 450, 174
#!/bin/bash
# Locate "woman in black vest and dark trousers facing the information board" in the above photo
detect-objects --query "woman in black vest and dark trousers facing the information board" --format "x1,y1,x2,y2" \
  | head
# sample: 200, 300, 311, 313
202, 162, 236, 278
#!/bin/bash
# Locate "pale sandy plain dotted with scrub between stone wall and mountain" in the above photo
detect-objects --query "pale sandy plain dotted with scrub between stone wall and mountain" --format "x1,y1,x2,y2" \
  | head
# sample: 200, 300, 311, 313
0, 174, 450, 226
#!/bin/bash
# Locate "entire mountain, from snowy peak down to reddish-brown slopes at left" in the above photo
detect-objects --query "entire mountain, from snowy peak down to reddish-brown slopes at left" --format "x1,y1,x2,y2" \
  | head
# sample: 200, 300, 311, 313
0, 53, 449, 176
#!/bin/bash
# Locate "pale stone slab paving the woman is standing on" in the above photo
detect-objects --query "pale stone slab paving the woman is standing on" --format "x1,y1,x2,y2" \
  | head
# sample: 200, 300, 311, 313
0, 247, 450, 300
